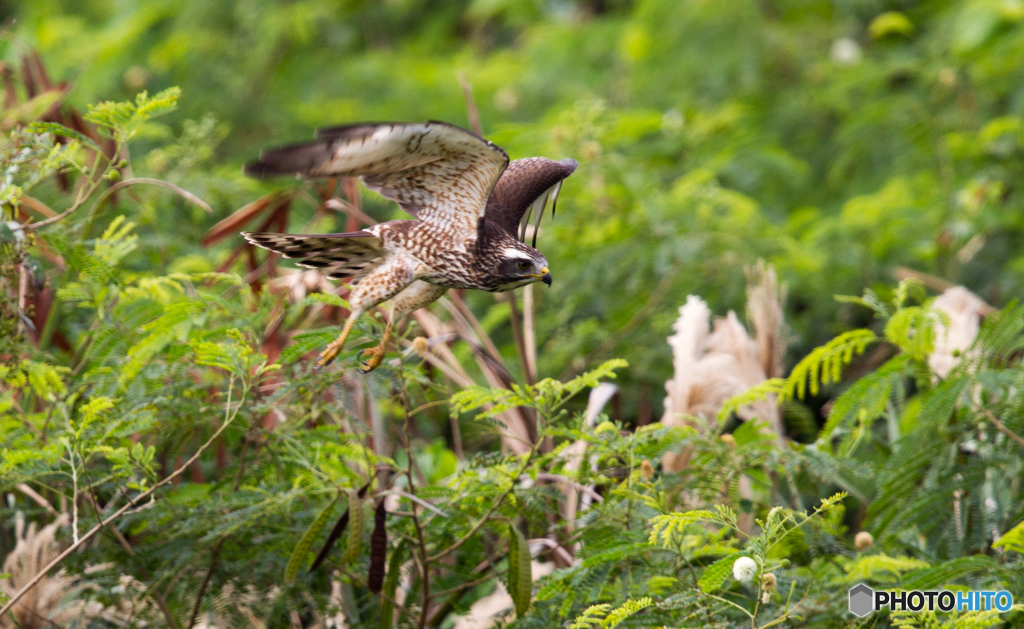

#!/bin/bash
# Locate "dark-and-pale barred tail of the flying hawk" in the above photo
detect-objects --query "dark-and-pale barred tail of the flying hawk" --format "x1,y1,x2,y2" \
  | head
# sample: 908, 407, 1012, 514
242, 232, 384, 280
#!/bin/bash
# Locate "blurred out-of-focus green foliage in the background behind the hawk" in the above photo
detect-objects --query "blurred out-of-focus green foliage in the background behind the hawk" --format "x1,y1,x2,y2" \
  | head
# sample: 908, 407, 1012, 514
8, 0, 1024, 419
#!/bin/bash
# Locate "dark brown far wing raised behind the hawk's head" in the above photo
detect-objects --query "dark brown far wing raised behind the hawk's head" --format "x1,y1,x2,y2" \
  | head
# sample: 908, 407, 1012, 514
484, 158, 580, 246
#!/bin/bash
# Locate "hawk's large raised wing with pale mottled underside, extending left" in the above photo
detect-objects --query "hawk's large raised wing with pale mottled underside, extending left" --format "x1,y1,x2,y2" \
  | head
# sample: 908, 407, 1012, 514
245, 122, 509, 238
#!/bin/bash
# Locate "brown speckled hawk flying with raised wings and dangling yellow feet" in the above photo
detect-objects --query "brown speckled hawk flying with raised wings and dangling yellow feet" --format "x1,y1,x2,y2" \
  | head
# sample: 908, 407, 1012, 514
243, 122, 579, 373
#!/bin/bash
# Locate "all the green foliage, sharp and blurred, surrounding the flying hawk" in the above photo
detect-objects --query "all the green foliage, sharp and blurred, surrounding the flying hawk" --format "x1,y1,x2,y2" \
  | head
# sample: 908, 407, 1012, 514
6, 0, 1024, 628
